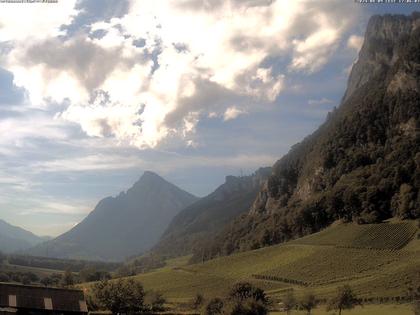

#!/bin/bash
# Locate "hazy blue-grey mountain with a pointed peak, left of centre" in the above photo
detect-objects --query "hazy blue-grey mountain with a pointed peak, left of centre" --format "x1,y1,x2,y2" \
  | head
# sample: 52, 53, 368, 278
27, 172, 197, 261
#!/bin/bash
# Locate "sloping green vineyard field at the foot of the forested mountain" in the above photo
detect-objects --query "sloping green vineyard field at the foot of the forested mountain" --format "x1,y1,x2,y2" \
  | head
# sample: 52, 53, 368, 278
82, 221, 420, 314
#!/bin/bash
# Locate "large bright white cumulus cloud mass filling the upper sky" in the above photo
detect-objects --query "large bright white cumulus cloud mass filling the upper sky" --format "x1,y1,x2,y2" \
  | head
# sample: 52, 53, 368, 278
0, 0, 360, 148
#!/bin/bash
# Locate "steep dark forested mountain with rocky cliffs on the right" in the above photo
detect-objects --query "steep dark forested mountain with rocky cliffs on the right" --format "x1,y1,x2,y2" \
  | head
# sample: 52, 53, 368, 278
195, 13, 420, 260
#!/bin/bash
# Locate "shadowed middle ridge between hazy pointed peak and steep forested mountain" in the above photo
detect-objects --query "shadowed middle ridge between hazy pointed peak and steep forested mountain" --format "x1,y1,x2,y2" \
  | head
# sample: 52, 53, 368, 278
153, 167, 271, 256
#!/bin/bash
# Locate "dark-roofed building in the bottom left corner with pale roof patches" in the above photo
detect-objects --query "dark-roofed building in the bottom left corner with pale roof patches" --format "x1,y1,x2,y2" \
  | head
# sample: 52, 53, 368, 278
0, 283, 88, 315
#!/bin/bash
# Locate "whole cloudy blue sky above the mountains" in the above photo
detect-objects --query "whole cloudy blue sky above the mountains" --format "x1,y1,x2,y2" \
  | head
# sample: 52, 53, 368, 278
0, 0, 420, 236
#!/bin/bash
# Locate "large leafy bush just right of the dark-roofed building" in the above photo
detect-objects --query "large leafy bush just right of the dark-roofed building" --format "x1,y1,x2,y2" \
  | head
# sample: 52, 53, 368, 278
93, 279, 146, 314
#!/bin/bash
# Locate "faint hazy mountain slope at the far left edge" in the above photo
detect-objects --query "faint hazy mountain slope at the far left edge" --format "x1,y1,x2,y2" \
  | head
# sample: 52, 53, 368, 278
0, 220, 43, 253
